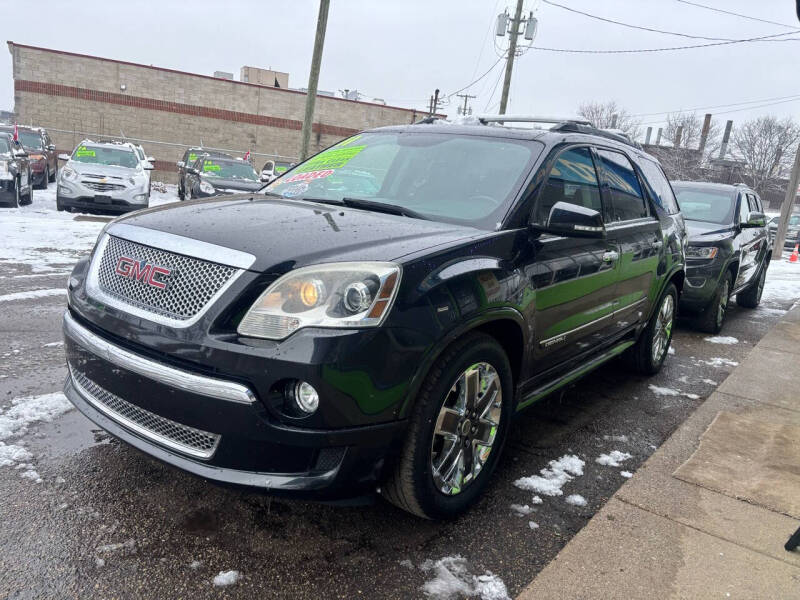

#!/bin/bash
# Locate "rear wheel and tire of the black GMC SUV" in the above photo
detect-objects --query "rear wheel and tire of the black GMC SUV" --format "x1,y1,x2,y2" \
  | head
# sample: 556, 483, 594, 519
627, 283, 678, 375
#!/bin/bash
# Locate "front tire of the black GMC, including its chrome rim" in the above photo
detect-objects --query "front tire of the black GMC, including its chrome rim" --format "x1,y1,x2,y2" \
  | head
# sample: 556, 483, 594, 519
381, 333, 514, 519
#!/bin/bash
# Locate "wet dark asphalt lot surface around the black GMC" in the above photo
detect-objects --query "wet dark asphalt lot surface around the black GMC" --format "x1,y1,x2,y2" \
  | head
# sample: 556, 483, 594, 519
0, 189, 800, 599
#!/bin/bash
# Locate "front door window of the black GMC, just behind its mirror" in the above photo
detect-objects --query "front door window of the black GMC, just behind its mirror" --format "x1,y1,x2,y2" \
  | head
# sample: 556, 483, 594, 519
534, 147, 603, 225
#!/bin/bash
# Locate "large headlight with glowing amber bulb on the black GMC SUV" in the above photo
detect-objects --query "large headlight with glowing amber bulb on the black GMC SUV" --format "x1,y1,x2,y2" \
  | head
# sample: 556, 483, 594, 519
238, 262, 400, 340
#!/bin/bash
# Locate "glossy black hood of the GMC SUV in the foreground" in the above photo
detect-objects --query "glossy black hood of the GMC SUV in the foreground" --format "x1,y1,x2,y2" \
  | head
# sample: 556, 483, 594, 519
115, 195, 489, 273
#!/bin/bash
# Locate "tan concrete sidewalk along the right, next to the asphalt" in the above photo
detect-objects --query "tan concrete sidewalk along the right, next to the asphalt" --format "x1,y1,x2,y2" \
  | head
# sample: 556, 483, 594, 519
518, 307, 800, 600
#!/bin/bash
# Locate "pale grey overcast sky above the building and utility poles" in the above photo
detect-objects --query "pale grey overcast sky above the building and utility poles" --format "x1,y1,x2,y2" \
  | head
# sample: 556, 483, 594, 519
0, 0, 800, 135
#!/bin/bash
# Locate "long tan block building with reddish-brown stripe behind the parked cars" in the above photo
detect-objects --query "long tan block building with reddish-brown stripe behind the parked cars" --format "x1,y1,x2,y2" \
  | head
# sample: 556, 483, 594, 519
8, 42, 432, 181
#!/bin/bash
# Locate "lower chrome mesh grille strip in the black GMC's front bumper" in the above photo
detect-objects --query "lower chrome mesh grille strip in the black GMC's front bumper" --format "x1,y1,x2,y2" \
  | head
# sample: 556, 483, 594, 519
70, 365, 221, 459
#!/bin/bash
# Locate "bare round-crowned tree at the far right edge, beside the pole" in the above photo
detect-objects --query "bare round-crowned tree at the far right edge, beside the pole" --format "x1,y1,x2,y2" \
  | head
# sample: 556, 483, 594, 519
733, 116, 800, 193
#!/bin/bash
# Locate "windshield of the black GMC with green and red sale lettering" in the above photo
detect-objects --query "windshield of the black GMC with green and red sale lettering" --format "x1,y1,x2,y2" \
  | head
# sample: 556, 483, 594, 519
265, 132, 544, 230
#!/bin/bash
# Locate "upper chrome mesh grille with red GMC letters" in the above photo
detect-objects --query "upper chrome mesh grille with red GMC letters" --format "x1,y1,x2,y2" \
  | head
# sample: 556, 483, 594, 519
92, 235, 240, 326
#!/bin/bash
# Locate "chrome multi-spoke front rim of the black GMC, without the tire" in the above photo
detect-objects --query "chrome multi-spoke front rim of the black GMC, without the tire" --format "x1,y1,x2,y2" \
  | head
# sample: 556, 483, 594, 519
431, 362, 503, 496
